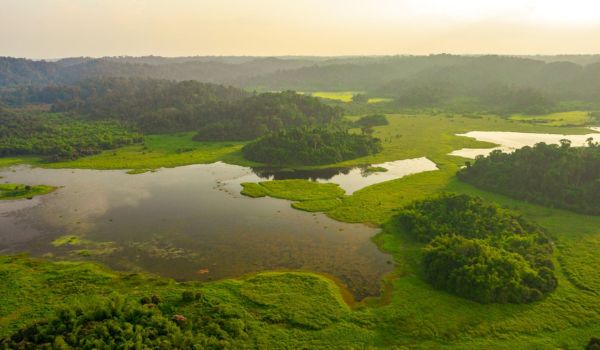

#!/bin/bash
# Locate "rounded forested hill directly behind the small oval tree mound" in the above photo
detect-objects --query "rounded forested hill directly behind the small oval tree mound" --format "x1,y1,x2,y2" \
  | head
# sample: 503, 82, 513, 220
194, 91, 342, 141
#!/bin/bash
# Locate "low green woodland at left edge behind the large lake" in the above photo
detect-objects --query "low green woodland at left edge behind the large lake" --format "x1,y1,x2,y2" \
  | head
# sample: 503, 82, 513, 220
0, 107, 143, 160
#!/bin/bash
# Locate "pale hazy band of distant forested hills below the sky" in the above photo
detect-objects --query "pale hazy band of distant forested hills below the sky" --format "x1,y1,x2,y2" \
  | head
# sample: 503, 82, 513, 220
0, 54, 600, 113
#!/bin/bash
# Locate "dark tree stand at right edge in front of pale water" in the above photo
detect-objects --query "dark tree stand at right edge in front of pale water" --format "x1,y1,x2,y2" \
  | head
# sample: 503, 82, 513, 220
458, 140, 600, 215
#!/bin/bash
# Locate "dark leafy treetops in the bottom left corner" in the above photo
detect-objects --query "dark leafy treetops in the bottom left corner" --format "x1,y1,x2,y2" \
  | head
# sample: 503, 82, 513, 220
0, 296, 246, 349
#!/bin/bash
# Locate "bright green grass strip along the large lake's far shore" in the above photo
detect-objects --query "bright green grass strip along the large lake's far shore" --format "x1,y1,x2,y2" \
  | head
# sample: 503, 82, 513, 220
38, 133, 250, 174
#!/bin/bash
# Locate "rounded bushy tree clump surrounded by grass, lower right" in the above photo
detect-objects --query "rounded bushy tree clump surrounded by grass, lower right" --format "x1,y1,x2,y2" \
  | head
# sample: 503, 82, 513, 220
394, 194, 557, 303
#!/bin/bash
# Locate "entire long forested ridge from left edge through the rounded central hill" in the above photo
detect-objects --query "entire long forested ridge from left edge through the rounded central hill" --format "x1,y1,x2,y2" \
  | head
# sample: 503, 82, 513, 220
3, 78, 342, 141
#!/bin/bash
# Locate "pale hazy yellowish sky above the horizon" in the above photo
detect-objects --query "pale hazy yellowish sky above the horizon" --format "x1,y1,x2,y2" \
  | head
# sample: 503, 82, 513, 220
0, 0, 600, 58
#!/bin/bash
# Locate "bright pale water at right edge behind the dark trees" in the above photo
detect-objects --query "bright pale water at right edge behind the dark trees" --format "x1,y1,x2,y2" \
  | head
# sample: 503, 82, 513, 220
450, 127, 600, 158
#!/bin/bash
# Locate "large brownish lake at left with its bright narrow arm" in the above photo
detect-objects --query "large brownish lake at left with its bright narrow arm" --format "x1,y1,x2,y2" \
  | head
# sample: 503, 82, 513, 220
0, 158, 435, 298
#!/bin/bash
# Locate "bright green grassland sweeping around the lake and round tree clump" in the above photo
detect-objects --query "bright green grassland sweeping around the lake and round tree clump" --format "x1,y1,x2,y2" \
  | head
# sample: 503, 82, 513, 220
0, 113, 600, 349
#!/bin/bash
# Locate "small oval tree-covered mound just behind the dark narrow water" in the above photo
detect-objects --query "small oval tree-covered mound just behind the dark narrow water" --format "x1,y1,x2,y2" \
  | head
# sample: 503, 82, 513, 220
242, 128, 382, 165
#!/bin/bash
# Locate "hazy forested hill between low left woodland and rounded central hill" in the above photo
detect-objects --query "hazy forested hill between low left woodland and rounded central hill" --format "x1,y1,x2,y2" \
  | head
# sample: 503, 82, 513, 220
40, 78, 248, 133
